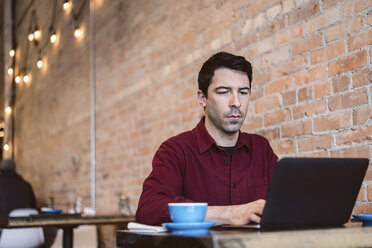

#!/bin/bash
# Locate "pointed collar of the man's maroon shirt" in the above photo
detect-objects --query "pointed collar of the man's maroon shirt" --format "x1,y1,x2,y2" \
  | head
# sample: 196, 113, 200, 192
195, 117, 249, 153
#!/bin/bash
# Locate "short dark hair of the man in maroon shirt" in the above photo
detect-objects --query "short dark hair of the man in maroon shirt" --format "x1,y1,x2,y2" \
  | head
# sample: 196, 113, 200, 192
198, 52, 252, 97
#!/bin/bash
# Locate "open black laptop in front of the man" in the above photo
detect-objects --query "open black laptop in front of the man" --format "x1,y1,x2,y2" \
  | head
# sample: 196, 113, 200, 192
235, 158, 369, 229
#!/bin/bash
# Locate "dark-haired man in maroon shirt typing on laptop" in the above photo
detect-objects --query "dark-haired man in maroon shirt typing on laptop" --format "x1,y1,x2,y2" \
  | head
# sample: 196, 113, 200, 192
136, 52, 277, 225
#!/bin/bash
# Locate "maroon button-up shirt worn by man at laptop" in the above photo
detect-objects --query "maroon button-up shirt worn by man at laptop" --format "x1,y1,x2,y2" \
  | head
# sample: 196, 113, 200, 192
136, 118, 278, 225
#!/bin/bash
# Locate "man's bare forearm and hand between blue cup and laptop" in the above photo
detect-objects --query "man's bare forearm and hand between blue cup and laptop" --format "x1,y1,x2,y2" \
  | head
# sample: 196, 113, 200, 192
205, 199, 266, 225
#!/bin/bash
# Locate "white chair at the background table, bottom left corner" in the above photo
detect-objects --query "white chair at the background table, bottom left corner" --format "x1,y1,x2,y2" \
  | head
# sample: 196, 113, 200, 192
0, 208, 44, 248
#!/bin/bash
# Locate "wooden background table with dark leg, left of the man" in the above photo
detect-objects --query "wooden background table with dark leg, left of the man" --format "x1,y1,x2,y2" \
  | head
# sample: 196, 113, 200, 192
0, 214, 134, 248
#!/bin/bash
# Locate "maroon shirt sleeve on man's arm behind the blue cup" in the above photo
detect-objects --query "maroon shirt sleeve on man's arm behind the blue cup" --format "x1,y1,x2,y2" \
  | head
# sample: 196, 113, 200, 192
136, 141, 192, 225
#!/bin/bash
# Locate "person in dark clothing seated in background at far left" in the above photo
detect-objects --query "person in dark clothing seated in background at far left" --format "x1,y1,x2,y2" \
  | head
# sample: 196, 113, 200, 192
0, 160, 36, 217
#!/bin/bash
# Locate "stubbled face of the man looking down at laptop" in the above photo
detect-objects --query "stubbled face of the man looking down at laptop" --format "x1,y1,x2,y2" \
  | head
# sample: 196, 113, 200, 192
198, 68, 250, 137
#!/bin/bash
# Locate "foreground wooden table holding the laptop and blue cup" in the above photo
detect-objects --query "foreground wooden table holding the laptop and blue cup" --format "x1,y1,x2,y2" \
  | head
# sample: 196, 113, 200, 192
116, 224, 372, 248
